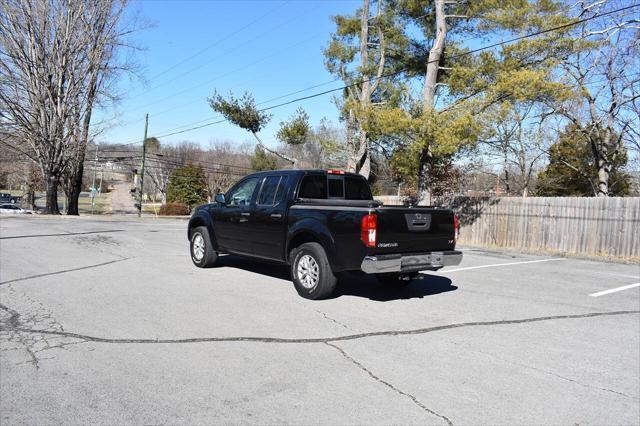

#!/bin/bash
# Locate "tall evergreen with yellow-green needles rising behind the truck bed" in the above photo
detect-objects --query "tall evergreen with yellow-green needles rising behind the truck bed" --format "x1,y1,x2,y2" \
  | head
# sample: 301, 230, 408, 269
324, 0, 574, 197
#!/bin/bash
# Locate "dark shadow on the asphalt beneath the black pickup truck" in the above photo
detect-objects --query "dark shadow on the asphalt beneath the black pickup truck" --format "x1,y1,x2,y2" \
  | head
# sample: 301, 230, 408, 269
218, 255, 458, 302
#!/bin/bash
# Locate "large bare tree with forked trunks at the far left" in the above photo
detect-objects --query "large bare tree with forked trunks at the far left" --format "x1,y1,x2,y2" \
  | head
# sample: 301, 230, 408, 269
0, 0, 134, 214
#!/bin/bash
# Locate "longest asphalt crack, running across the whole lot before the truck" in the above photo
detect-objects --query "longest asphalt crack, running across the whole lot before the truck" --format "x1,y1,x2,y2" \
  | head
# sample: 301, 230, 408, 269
0, 310, 640, 344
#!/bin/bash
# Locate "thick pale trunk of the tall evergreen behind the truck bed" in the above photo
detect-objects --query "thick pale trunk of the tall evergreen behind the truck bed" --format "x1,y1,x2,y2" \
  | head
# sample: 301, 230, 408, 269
417, 0, 447, 199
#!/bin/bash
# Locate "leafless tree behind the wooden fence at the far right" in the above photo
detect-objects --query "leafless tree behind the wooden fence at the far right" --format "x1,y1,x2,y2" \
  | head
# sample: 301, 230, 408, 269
551, 0, 640, 197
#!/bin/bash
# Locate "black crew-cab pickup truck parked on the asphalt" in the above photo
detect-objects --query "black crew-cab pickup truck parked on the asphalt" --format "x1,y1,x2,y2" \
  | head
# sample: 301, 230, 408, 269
188, 170, 462, 299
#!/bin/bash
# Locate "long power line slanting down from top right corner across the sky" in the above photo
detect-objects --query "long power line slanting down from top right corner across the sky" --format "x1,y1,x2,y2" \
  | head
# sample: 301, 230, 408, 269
111, 3, 640, 145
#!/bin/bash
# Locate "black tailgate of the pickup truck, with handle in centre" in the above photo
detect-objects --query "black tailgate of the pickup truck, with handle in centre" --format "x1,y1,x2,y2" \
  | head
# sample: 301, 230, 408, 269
375, 206, 455, 254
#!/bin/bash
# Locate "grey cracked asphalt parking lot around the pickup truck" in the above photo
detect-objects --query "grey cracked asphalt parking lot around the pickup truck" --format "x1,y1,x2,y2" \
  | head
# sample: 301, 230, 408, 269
0, 217, 640, 425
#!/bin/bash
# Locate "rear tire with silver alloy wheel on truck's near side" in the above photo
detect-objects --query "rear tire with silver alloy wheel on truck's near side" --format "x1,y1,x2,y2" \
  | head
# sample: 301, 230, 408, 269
290, 243, 338, 300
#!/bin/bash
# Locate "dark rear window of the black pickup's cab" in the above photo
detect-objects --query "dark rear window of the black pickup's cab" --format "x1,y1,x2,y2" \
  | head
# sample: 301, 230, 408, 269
298, 175, 372, 200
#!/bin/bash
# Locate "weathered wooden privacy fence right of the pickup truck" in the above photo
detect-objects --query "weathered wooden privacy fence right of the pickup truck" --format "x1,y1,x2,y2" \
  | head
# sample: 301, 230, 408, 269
444, 197, 640, 257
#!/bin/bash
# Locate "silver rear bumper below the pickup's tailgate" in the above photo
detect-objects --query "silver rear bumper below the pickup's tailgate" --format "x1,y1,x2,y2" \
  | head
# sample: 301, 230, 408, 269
360, 250, 462, 274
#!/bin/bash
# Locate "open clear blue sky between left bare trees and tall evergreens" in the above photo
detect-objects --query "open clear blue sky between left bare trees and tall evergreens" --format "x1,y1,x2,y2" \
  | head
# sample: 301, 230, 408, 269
96, 0, 361, 147
